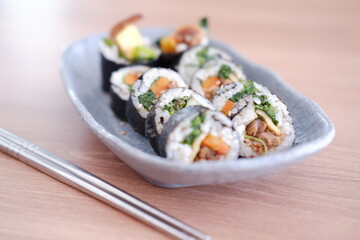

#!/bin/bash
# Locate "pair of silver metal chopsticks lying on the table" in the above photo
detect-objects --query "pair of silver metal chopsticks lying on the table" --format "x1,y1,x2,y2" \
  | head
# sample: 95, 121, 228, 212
0, 128, 211, 240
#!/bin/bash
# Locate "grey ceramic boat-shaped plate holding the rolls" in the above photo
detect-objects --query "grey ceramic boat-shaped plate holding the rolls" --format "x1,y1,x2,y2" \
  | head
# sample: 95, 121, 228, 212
61, 28, 335, 187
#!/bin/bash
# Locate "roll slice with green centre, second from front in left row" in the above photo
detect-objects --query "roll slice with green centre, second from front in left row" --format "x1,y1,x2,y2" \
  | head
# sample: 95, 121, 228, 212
145, 88, 215, 152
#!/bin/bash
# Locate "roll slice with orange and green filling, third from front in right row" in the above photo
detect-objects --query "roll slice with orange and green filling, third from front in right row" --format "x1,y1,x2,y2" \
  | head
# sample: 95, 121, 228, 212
190, 59, 245, 100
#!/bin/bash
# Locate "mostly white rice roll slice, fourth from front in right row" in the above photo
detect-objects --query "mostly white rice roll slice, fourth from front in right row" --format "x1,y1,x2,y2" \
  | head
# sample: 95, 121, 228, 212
178, 46, 232, 85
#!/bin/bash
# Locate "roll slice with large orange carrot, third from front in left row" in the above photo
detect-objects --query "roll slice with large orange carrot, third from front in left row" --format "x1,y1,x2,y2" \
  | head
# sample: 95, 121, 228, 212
126, 68, 186, 135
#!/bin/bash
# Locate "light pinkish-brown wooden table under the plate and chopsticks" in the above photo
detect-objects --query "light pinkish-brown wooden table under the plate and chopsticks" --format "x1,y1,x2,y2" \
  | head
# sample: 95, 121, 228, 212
0, 0, 360, 239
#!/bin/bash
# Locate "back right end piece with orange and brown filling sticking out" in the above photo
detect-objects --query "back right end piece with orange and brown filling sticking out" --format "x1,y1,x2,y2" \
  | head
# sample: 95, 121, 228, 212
159, 18, 209, 69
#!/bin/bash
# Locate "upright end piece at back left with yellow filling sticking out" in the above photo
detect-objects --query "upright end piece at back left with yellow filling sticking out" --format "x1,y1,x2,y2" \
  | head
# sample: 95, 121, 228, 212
99, 14, 160, 92
